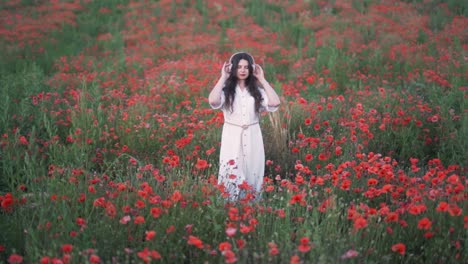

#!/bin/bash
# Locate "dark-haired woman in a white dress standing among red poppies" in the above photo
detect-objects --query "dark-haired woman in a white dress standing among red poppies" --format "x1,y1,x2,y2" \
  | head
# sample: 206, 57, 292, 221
208, 52, 280, 200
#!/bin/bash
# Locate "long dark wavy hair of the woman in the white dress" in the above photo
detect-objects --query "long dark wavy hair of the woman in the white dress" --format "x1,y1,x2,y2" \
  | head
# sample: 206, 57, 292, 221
223, 52, 262, 113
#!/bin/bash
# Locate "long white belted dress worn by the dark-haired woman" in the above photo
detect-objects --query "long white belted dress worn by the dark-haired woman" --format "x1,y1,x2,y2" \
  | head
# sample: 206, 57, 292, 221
211, 86, 278, 199
